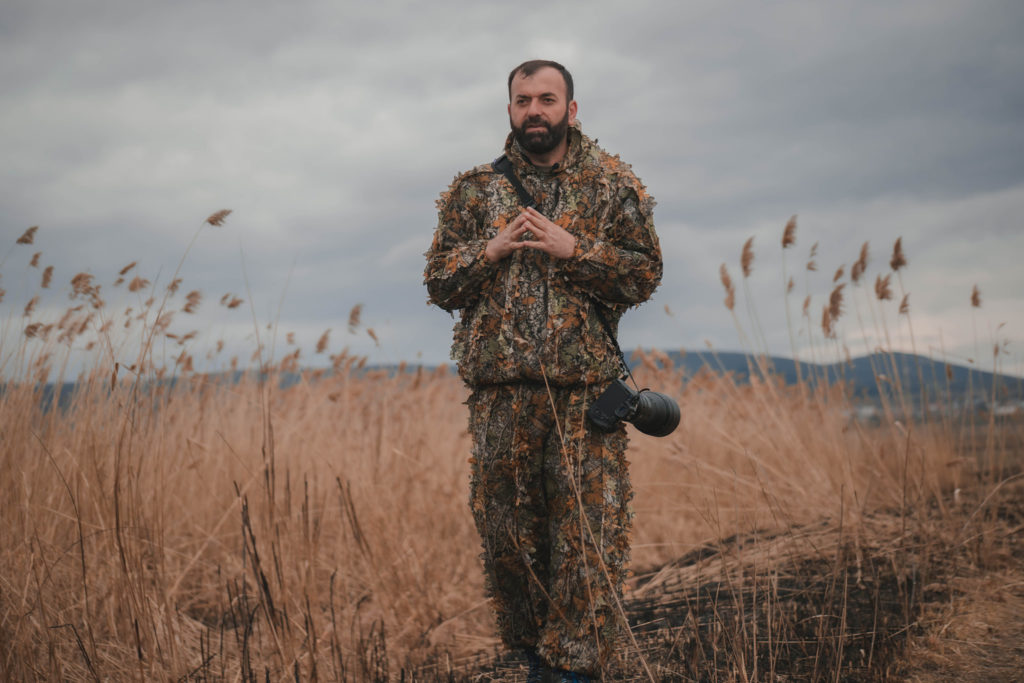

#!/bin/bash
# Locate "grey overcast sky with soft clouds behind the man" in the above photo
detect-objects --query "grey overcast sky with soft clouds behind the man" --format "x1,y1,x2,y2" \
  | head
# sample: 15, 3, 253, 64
0, 0, 1024, 372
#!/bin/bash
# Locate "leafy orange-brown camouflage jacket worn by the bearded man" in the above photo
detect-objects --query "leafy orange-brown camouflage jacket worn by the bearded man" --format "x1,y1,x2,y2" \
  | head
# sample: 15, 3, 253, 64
424, 126, 662, 386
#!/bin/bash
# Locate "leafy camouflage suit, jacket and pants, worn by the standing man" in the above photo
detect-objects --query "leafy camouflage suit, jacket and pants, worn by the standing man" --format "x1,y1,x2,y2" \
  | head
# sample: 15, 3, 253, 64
424, 126, 662, 675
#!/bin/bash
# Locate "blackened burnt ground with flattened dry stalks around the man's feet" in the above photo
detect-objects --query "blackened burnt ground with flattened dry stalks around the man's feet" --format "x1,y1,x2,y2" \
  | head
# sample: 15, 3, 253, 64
398, 478, 1024, 682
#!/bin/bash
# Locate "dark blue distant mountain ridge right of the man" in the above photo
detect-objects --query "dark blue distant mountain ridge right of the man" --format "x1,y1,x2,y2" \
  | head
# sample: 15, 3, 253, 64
647, 351, 1024, 403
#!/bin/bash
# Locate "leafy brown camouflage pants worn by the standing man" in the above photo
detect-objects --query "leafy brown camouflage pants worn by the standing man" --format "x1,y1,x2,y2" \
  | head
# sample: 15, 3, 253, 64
467, 384, 633, 676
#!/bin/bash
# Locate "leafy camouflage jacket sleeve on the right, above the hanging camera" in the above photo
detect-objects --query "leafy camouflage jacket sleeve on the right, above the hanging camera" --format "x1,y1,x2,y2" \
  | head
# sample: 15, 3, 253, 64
562, 181, 662, 305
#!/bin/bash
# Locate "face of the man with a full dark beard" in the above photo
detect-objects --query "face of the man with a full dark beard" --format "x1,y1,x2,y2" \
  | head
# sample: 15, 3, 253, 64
509, 67, 577, 155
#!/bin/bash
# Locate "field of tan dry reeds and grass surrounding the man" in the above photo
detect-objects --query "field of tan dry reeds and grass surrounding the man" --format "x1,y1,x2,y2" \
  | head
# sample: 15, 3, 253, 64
0, 214, 1024, 681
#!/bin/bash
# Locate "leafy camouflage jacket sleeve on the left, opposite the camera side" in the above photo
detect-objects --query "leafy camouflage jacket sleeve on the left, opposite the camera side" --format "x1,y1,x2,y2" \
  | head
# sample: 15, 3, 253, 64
423, 179, 498, 310
